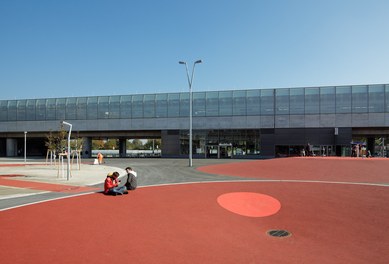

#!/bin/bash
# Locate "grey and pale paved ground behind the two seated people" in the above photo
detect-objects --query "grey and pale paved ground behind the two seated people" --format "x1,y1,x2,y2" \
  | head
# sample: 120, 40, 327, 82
0, 158, 249, 210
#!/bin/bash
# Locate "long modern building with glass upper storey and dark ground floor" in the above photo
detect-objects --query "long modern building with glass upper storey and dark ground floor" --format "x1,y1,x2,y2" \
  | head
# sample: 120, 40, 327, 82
0, 84, 389, 158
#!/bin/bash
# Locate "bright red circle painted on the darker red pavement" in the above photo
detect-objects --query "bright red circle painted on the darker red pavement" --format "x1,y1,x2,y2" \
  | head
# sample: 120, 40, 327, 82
217, 192, 281, 217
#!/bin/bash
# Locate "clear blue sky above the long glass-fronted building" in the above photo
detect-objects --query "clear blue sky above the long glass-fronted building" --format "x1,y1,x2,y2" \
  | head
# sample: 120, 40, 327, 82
0, 0, 389, 99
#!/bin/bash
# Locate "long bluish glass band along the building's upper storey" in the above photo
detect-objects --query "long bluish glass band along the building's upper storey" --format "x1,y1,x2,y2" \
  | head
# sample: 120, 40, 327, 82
0, 84, 389, 121
